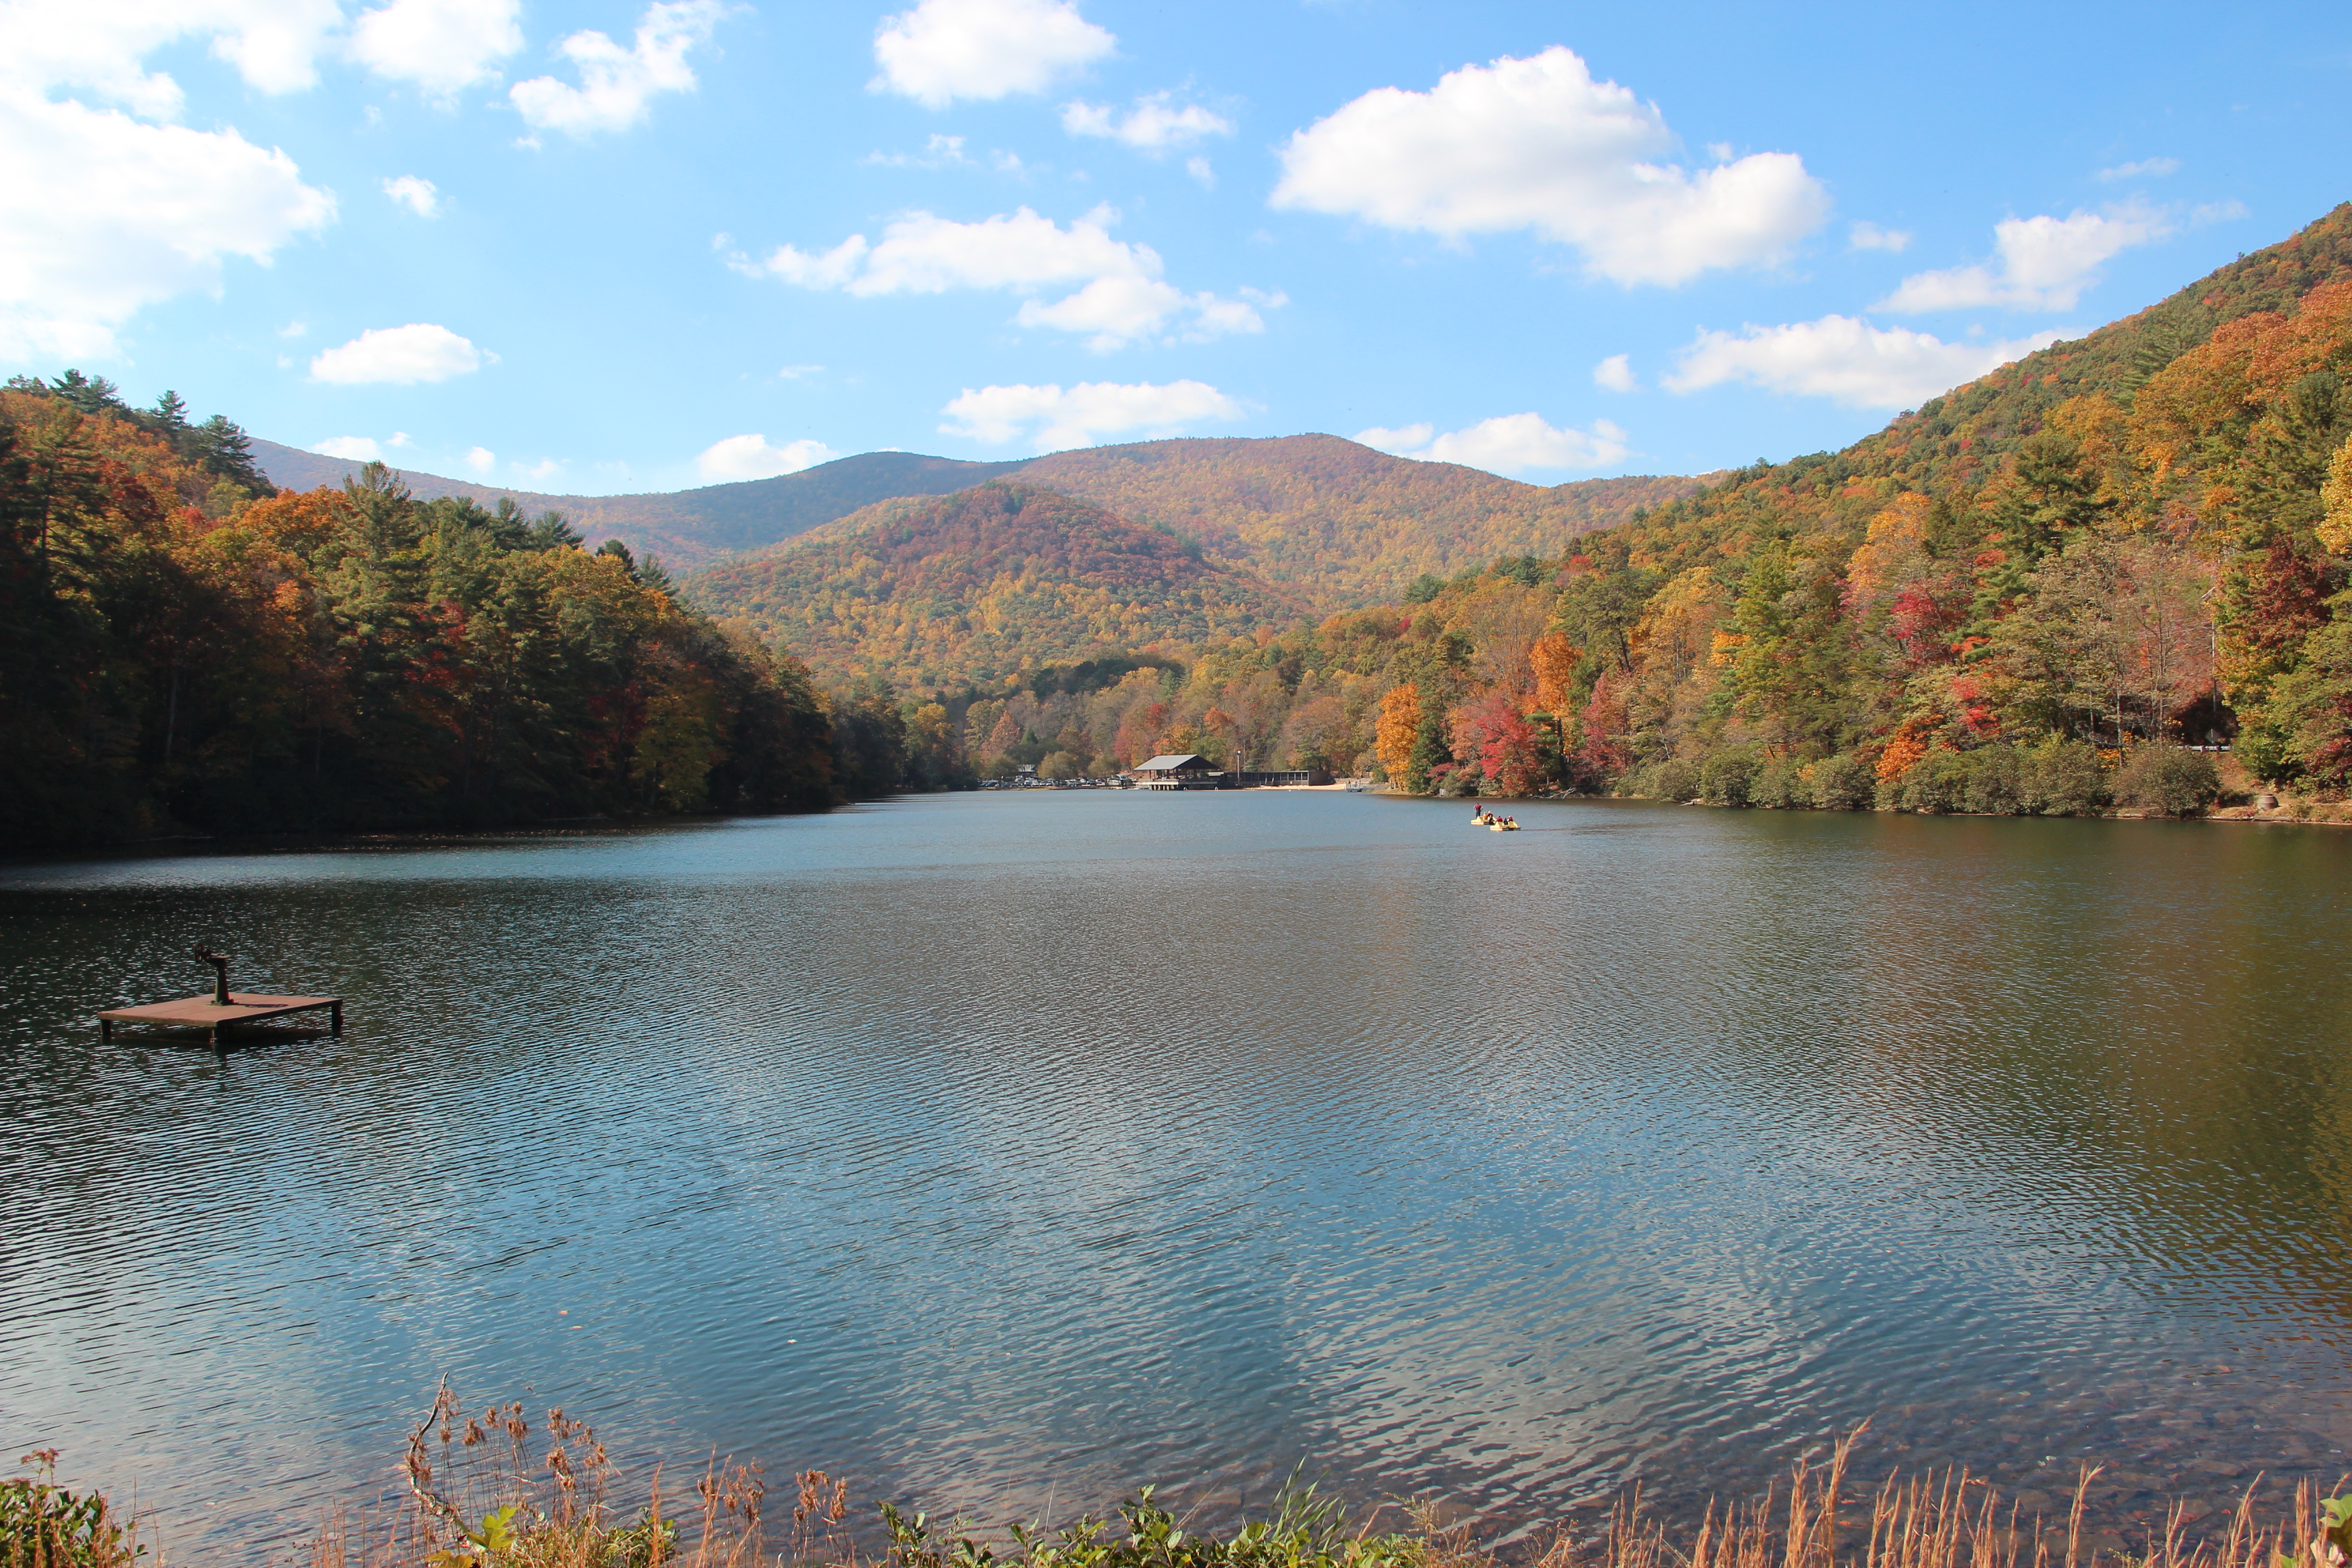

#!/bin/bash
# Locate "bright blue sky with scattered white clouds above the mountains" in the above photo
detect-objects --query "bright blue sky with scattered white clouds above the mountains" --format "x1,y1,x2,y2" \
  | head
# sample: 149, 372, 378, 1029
0, 0, 2352, 493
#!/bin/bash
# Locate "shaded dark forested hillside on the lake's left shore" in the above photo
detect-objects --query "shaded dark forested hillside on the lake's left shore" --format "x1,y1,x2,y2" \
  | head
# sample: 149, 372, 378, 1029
0, 378, 898, 849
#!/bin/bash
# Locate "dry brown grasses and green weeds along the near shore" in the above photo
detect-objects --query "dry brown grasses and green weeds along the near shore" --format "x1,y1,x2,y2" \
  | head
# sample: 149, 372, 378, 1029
18, 1385, 2352, 1568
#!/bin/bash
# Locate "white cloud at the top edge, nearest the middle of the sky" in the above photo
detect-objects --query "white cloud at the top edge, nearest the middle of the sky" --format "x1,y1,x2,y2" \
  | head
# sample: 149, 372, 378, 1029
870, 0, 1120, 108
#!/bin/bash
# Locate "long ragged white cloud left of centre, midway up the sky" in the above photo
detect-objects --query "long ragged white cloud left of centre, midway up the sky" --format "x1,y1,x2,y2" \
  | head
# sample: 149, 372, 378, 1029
727, 207, 1284, 353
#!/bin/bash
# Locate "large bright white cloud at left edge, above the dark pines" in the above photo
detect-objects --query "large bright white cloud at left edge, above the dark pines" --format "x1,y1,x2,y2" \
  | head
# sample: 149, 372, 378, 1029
0, 93, 334, 362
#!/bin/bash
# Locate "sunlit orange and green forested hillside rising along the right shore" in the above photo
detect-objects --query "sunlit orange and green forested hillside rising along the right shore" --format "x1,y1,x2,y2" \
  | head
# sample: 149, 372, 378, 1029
889, 207, 2352, 811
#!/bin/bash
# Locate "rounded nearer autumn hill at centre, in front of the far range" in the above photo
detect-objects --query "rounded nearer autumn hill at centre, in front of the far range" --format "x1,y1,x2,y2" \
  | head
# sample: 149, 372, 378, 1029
687, 480, 1308, 687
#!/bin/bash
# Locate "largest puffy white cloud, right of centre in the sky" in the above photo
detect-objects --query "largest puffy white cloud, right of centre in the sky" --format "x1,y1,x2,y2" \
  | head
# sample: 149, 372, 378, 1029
1270, 45, 1830, 284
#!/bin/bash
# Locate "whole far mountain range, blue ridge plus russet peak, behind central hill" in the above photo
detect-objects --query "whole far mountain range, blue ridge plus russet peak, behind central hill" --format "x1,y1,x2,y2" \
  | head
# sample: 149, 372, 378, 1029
254, 435, 1705, 594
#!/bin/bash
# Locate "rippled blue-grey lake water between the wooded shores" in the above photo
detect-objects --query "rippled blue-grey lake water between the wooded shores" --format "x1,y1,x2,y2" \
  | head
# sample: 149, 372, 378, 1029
0, 792, 2352, 1563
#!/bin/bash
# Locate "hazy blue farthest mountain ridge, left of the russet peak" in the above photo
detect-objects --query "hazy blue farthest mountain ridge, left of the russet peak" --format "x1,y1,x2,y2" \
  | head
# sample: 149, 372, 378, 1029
254, 440, 1021, 569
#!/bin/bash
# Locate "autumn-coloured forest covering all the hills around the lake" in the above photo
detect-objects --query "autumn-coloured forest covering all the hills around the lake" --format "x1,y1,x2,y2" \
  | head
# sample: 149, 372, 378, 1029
0, 207, 2352, 844
